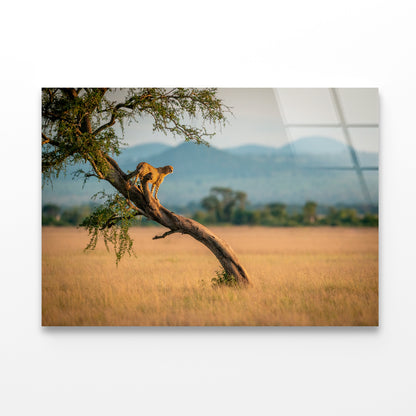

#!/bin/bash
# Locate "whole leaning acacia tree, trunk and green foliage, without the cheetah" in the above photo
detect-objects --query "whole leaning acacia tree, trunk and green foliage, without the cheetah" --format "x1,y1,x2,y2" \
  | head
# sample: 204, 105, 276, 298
42, 88, 249, 283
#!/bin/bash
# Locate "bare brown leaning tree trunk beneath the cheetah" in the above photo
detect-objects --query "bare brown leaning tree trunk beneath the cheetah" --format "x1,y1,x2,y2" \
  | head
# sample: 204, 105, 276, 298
101, 157, 250, 284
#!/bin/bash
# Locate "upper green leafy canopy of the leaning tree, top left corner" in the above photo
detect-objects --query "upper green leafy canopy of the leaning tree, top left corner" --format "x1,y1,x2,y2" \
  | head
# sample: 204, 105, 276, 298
42, 88, 228, 177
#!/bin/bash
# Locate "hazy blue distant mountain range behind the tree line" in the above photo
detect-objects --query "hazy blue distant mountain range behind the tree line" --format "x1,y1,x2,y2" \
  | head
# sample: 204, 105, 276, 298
43, 137, 378, 207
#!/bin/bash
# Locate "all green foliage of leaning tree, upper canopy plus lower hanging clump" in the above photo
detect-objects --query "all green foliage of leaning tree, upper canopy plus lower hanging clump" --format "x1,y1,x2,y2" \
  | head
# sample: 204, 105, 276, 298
42, 88, 229, 260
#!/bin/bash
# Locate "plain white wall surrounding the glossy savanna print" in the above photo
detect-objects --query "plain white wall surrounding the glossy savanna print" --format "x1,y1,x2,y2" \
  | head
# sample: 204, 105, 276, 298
0, 0, 416, 416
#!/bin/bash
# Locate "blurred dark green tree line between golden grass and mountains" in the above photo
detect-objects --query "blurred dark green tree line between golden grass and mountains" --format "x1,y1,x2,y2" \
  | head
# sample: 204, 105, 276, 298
42, 187, 378, 227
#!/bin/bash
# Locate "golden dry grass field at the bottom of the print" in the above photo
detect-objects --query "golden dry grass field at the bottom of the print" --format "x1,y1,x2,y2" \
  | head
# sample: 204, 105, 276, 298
42, 227, 378, 326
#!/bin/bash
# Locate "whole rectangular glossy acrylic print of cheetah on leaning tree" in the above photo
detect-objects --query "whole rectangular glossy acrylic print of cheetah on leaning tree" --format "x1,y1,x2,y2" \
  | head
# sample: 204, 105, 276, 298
42, 88, 379, 326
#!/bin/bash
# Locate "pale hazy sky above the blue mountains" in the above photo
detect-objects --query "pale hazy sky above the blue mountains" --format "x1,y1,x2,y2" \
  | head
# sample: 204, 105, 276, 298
118, 88, 379, 152
